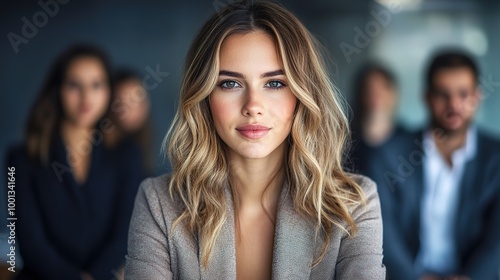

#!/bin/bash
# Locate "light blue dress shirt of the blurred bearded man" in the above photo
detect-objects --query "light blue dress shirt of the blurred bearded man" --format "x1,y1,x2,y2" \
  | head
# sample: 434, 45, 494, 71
416, 126, 477, 275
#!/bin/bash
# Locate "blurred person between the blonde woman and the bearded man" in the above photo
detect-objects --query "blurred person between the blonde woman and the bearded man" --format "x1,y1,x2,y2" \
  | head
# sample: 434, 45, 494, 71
346, 62, 407, 177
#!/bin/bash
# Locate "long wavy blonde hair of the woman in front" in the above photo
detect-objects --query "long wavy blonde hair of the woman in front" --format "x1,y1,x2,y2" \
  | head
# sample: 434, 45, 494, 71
163, 1, 364, 267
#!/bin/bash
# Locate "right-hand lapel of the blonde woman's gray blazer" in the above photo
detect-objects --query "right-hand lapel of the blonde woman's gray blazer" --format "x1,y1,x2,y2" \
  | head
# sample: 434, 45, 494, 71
272, 184, 316, 279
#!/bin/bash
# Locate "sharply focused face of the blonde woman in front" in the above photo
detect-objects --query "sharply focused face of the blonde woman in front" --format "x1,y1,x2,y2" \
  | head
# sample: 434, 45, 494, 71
209, 31, 297, 159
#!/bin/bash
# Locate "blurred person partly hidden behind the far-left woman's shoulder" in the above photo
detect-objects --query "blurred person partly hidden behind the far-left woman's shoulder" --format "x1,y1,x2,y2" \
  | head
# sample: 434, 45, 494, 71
104, 70, 154, 176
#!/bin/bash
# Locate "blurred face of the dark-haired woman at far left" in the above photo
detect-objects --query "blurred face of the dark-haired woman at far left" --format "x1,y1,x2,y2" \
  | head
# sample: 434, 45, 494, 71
61, 57, 110, 128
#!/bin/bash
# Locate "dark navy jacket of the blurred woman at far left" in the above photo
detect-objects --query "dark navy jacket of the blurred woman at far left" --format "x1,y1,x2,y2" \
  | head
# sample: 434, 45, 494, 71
7, 137, 142, 280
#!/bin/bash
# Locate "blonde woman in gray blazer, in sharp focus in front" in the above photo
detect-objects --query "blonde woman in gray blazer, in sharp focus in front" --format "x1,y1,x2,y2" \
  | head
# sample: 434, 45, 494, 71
125, 1, 385, 279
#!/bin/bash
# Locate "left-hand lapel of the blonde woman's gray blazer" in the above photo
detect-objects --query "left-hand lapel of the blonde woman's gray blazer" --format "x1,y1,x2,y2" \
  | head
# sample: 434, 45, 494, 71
198, 187, 236, 279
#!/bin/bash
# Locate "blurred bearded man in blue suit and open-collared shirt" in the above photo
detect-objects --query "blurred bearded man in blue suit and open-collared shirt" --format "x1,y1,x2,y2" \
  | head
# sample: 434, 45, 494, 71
374, 51, 500, 280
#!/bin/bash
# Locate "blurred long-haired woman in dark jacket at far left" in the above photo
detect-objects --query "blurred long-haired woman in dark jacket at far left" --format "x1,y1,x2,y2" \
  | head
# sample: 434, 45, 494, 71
8, 45, 142, 280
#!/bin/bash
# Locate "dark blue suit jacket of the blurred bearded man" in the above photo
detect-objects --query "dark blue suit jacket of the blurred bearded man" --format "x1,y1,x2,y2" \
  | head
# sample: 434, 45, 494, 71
363, 128, 500, 280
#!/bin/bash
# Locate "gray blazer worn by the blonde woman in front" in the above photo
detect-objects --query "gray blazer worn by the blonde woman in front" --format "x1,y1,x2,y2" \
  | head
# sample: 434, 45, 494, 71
125, 175, 385, 280
